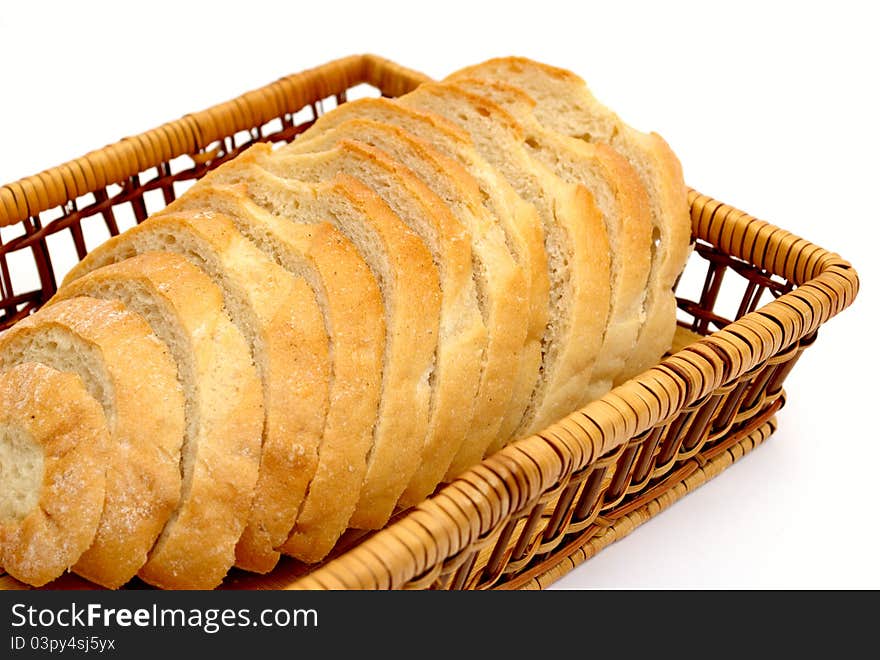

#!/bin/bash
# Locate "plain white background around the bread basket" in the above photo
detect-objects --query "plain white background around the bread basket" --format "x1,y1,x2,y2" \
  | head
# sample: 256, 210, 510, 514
0, 0, 880, 588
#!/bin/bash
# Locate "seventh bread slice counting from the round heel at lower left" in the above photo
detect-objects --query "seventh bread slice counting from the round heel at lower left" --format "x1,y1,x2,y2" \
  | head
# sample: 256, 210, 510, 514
266, 140, 487, 507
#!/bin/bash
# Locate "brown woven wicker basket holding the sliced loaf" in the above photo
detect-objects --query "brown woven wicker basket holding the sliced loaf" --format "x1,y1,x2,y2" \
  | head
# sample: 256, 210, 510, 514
0, 55, 858, 589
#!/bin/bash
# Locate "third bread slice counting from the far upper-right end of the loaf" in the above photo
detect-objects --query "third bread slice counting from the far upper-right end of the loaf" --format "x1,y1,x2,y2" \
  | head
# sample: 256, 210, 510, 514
398, 83, 610, 437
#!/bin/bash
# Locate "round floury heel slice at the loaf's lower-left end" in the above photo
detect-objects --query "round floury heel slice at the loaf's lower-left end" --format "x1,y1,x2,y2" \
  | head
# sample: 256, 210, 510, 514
0, 362, 110, 587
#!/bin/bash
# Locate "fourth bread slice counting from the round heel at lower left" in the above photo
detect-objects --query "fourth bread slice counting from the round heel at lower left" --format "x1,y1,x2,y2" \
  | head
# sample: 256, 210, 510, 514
65, 212, 330, 573
